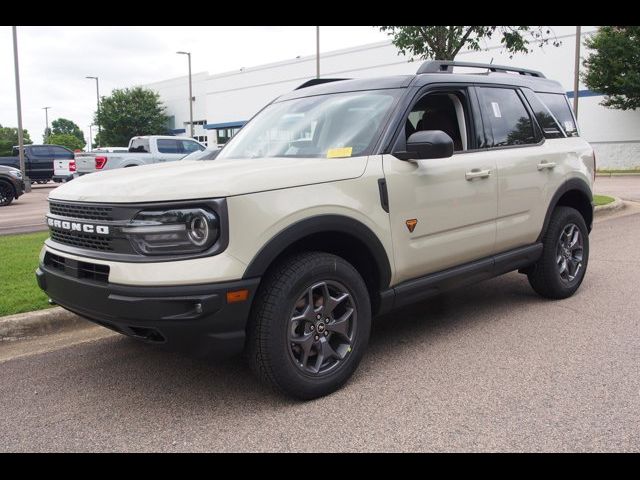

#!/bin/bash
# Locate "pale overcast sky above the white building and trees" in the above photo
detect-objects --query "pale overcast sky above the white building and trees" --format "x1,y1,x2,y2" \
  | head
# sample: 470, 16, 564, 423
0, 26, 388, 143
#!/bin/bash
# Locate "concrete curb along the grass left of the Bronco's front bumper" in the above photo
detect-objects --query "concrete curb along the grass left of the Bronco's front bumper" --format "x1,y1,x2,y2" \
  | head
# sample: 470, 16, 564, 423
0, 307, 87, 341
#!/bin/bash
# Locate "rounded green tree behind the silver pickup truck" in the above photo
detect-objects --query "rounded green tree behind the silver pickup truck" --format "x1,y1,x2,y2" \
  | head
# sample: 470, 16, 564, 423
94, 87, 169, 146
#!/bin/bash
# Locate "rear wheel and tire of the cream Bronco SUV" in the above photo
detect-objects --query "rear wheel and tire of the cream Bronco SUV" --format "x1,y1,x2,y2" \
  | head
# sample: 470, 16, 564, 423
527, 207, 589, 299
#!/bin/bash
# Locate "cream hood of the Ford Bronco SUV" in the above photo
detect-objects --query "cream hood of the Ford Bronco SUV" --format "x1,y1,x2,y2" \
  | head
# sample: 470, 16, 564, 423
49, 157, 367, 203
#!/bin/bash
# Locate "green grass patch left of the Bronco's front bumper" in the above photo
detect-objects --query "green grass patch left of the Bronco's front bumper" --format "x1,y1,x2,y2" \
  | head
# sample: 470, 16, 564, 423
0, 232, 50, 316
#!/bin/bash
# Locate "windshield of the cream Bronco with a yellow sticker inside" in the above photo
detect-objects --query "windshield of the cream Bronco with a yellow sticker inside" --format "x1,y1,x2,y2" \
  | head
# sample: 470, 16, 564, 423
218, 90, 400, 159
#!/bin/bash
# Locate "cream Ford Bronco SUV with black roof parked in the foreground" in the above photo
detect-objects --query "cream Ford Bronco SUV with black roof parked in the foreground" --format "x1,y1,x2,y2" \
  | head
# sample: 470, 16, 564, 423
37, 61, 595, 399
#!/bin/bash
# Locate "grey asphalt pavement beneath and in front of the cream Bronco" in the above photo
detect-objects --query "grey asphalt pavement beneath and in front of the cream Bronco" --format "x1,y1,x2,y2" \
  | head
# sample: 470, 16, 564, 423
0, 207, 640, 452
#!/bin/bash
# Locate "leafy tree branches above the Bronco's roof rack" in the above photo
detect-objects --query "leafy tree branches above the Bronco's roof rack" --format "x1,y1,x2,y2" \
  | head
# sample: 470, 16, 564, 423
380, 25, 560, 60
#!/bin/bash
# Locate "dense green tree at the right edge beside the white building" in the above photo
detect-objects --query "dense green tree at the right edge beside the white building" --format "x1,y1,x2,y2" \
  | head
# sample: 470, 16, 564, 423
582, 26, 640, 110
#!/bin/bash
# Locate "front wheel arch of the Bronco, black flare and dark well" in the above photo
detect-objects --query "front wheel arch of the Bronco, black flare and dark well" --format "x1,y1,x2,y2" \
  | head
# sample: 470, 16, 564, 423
243, 215, 391, 309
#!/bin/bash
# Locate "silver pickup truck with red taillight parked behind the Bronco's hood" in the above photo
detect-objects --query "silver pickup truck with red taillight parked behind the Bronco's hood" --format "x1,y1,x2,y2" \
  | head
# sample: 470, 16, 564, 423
76, 135, 206, 175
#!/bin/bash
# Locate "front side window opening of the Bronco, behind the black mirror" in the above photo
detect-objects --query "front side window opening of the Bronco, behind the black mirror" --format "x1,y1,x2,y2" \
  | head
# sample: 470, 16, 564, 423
405, 91, 469, 152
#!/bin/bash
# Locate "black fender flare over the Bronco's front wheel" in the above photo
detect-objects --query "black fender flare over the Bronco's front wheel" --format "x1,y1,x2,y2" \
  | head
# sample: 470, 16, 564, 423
242, 215, 391, 290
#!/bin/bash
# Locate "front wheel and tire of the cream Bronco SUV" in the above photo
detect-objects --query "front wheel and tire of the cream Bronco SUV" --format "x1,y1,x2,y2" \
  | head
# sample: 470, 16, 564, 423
246, 252, 371, 400
